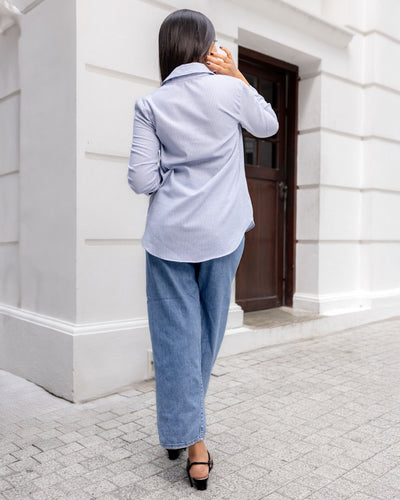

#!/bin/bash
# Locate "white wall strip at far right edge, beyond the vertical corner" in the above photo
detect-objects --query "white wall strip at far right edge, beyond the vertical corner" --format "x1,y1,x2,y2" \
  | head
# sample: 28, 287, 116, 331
362, 0, 400, 303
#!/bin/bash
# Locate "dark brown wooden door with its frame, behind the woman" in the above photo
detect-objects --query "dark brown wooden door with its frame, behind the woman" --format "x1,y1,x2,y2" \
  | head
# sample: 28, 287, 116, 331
236, 47, 298, 312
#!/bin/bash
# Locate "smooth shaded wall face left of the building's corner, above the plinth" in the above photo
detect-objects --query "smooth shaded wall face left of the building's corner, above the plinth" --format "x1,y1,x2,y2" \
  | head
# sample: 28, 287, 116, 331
19, 0, 76, 321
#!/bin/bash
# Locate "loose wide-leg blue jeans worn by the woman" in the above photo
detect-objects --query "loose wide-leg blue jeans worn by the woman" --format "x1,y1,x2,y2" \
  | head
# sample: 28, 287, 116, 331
146, 236, 245, 449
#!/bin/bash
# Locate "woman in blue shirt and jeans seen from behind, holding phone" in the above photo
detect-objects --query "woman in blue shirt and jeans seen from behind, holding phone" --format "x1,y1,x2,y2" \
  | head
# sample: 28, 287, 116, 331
128, 9, 279, 489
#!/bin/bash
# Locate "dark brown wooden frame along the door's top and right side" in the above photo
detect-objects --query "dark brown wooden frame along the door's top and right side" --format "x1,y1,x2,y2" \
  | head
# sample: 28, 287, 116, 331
238, 45, 300, 307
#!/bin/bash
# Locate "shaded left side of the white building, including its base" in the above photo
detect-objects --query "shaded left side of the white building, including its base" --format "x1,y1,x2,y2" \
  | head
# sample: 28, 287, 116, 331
0, 0, 76, 397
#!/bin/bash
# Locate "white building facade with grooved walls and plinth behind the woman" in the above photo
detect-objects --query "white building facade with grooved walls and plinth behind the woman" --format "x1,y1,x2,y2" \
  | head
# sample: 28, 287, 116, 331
0, 0, 400, 402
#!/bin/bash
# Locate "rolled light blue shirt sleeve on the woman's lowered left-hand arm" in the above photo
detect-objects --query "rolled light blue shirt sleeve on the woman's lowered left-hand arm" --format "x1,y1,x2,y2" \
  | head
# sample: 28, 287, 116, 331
127, 98, 162, 195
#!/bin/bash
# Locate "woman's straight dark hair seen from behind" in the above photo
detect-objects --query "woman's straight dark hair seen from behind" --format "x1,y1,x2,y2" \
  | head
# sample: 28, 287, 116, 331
158, 9, 215, 81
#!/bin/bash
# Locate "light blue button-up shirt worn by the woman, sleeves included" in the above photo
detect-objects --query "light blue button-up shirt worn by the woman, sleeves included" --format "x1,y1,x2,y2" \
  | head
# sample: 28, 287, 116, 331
127, 62, 279, 262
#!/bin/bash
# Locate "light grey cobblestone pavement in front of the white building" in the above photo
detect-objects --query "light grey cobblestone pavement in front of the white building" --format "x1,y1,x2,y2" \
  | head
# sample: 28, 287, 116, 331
0, 317, 400, 500
